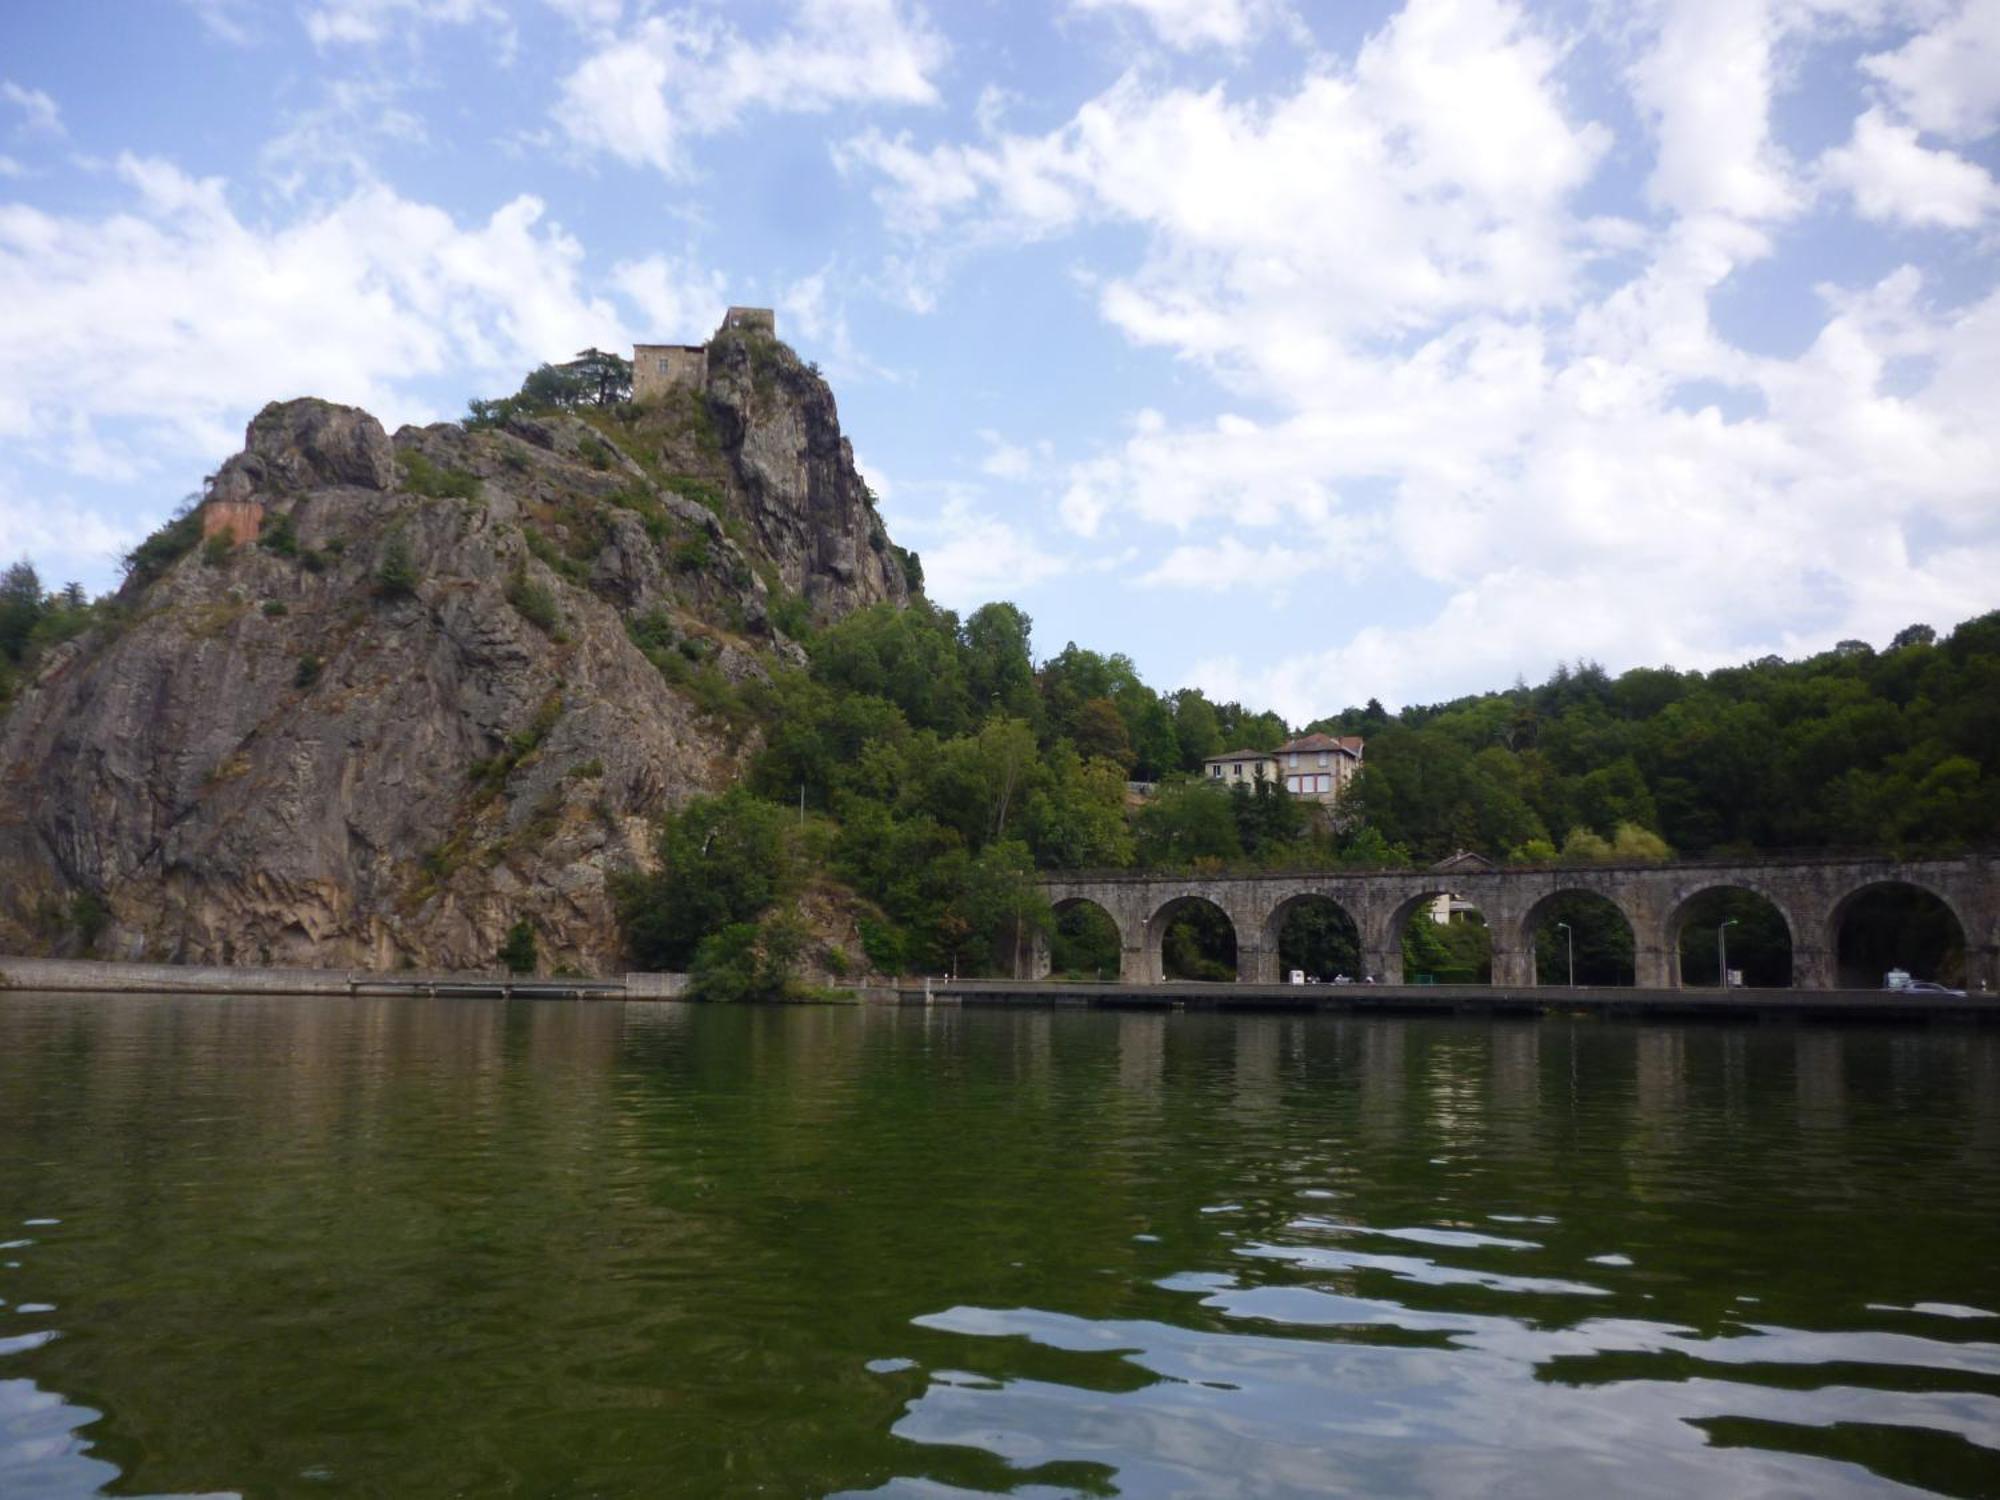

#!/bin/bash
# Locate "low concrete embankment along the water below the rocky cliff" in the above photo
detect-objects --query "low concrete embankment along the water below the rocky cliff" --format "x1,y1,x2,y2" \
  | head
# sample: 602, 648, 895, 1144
0, 958, 688, 1000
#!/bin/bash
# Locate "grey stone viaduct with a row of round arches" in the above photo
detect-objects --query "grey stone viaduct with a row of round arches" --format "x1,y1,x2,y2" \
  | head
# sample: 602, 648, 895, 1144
1024, 856, 2000, 990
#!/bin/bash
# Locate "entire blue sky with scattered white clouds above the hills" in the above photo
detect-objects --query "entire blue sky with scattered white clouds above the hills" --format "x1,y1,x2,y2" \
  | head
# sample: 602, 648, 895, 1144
0, 0, 2000, 724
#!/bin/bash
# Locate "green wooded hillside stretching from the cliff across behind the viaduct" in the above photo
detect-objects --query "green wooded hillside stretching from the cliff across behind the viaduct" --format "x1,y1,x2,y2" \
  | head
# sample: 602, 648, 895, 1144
626, 602, 2000, 992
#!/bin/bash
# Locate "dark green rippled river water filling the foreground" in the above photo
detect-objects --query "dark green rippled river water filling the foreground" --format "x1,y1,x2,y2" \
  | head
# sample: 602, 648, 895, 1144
0, 994, 2000, 1500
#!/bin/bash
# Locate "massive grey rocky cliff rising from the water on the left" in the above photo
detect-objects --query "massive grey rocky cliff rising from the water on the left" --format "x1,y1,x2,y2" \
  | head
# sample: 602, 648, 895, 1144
0, 322, 908, 970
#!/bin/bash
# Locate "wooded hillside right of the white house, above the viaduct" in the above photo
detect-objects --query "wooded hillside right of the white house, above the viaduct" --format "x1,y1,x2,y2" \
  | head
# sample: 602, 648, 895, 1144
1322, 614, 2000, 858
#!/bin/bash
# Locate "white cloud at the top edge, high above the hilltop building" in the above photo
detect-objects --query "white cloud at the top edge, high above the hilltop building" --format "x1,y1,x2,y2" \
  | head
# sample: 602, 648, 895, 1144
556, 0, 946, 174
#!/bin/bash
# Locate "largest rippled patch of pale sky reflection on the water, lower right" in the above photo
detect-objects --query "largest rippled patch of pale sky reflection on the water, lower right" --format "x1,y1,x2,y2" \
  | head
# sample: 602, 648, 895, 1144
888, 1296, 2000, 1498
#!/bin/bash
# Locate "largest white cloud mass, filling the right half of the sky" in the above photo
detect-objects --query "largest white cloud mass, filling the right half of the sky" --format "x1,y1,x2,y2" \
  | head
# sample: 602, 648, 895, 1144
840, 0, 2000, 718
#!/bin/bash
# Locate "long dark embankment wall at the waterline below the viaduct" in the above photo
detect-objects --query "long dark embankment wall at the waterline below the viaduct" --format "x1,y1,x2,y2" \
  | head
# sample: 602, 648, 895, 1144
896, 980, 2000, 1024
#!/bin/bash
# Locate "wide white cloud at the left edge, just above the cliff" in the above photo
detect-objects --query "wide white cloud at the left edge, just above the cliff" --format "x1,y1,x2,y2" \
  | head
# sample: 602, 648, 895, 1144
0, 156, 626, 464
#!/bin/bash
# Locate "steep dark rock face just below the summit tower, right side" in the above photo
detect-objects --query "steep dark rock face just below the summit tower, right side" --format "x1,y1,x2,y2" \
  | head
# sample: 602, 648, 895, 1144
708, 330, 910, 620
